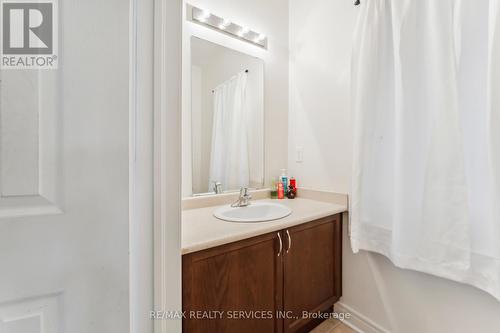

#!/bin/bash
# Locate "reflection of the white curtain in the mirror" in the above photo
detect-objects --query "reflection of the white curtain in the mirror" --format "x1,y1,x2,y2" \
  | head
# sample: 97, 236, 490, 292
208, 72, 250, 189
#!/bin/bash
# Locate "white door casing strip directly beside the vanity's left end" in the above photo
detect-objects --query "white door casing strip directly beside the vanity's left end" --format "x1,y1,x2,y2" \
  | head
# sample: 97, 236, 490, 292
153, 0, 182, 333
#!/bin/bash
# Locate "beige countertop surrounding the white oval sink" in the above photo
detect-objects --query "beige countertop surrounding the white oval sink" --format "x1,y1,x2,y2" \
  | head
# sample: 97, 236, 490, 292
182, 198, 347, 254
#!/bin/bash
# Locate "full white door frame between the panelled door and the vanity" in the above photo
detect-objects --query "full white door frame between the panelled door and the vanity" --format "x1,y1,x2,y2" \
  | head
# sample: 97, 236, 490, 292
129, 0, 182, 333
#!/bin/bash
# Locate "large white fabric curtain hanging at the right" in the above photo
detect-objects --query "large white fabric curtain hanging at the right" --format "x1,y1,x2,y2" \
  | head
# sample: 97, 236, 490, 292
351, 0, 500, 300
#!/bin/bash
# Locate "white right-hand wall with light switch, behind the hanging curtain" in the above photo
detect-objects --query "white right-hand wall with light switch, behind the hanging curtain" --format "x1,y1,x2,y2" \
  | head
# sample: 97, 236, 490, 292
289, 0, 500, 333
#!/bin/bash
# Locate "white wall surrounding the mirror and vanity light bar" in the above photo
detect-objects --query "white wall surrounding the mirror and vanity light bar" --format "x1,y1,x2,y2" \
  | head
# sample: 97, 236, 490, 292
182, 0, 288, 193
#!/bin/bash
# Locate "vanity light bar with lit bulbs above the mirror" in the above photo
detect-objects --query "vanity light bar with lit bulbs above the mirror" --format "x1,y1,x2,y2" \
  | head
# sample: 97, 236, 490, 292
186, 4, 268, 49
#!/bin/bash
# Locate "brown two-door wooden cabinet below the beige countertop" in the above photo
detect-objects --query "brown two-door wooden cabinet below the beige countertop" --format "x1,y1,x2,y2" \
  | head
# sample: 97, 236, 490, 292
182, 215, 342, 333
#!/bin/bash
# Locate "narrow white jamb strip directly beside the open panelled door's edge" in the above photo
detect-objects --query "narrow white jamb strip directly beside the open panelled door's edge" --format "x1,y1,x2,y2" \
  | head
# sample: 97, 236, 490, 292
129, 0, 154, 333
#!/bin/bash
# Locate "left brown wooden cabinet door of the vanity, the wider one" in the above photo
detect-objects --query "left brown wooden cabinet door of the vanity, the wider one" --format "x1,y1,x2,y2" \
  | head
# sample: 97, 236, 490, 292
183, 232, 283, 333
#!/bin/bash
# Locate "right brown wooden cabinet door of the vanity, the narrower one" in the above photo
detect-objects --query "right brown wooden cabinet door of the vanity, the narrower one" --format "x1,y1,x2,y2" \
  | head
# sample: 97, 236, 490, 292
283, 215, 342, 333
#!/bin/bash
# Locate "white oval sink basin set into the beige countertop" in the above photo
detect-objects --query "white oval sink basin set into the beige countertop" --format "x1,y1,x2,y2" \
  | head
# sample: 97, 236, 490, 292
214, 202, 292, 222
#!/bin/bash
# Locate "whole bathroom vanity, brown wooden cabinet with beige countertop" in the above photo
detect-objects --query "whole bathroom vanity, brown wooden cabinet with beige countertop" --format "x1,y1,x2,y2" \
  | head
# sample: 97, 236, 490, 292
182, 199, 346, 333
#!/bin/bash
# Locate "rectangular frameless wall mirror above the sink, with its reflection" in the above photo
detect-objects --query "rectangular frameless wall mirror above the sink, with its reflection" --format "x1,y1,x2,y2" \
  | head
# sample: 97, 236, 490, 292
191, 37, 264, 195
